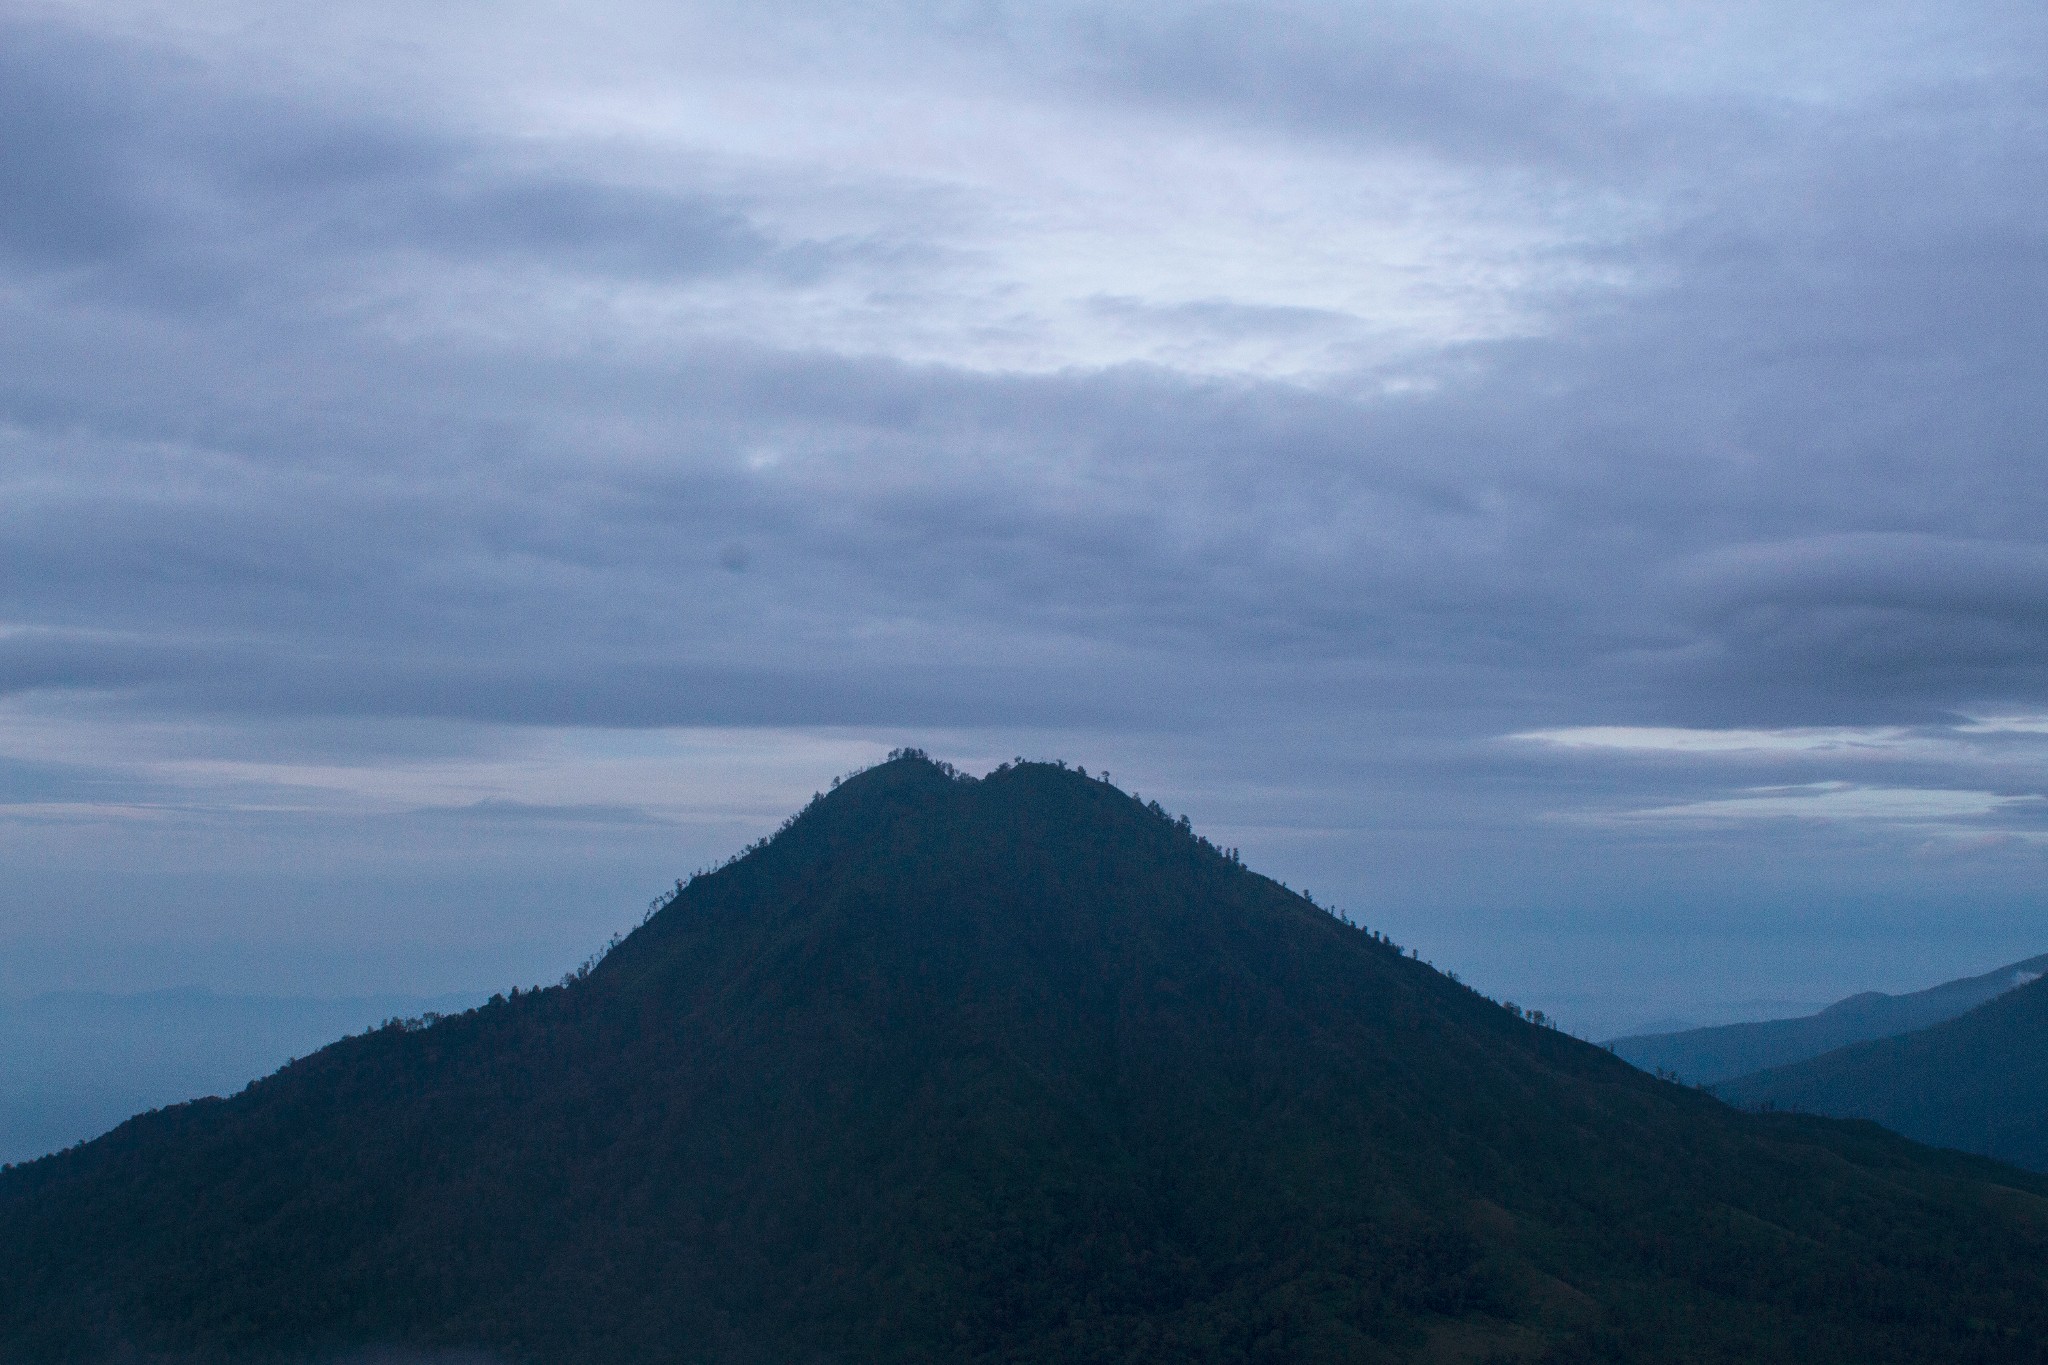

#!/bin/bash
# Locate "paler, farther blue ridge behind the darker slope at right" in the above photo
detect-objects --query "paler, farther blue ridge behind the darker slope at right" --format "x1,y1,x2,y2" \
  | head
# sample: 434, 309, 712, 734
1608, 954, 2048, 1085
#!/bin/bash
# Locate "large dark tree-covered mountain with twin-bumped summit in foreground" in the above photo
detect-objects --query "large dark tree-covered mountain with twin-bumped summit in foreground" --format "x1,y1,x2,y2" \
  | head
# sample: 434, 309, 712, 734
0, 753, 2048, 1365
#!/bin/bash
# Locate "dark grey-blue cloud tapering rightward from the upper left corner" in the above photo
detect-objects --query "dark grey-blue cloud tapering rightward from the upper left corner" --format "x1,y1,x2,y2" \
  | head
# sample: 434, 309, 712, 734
0, 20, 856, 321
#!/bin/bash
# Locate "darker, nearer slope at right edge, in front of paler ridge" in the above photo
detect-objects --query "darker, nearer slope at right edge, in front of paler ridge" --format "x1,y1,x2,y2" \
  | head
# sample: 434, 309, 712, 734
1714, 965, 2048, 1171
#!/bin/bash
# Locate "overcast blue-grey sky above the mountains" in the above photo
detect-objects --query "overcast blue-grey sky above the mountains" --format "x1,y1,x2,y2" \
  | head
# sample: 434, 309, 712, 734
0, 0, 2048, 1036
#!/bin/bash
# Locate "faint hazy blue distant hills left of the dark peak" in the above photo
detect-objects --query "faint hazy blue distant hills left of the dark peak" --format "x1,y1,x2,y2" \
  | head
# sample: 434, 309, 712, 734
0, 988, 477, 1162
